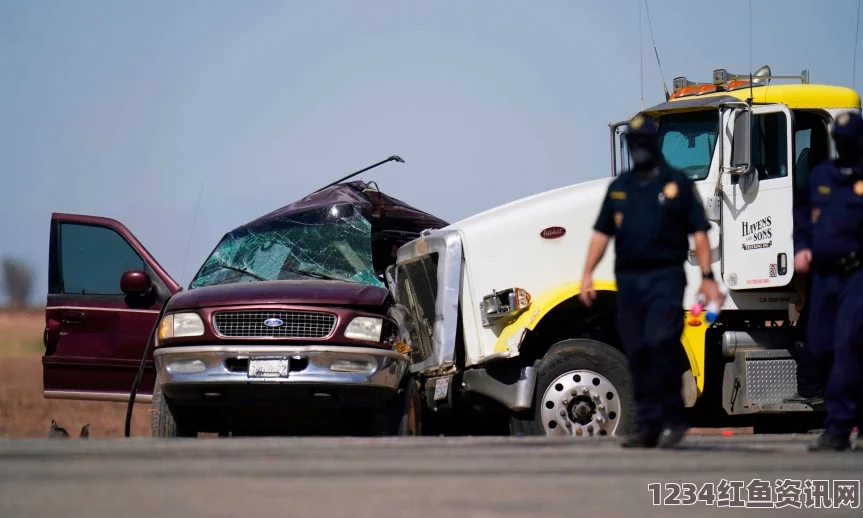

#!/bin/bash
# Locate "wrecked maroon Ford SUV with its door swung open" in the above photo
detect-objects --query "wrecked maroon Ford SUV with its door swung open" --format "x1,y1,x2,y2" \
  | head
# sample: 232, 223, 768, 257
42, 182, 447, 436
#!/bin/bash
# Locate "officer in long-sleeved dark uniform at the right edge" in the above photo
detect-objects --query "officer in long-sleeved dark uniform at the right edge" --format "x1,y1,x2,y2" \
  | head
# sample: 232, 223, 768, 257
794, 112, 863, 451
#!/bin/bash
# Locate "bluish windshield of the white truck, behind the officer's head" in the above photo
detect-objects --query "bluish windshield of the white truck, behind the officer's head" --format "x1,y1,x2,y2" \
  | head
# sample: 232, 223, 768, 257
659, 110, 719, 181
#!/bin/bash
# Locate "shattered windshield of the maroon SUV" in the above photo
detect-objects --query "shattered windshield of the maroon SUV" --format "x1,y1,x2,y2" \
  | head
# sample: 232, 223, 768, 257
189, 204, 384, 288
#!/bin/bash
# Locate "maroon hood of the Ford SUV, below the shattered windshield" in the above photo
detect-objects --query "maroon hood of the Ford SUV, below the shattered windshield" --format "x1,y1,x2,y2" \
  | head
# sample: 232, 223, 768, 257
166, 279, 390, 311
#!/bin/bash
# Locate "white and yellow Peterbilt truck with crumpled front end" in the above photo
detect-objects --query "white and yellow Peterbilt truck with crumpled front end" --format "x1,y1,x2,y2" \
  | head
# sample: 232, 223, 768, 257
387, 66, 861, 437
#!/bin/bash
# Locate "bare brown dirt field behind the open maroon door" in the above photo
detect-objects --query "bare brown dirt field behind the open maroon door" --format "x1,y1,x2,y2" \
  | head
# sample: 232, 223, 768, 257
0, 309, 150, 438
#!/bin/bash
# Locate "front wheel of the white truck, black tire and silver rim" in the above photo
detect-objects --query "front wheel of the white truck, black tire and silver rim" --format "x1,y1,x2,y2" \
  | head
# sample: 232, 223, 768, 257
510, 339, 635, 438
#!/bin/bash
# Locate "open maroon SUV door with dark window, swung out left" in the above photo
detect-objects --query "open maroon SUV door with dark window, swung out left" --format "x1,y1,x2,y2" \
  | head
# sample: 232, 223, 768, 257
42, 214, 180, 401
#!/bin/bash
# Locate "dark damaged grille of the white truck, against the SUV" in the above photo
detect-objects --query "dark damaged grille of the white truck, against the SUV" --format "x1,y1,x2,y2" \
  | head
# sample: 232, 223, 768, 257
396, 253, 438, 363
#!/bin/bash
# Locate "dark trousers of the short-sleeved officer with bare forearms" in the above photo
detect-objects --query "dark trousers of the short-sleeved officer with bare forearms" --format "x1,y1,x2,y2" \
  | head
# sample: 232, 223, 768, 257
615, 265, 686, 434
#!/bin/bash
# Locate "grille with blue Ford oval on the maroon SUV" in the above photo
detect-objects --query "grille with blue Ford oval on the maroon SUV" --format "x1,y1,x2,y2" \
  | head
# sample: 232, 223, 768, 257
213, 311, 336, 338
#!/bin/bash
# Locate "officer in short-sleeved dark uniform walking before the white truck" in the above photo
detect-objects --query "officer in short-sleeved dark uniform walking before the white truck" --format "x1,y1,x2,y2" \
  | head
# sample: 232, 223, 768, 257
580, 114, 722, 448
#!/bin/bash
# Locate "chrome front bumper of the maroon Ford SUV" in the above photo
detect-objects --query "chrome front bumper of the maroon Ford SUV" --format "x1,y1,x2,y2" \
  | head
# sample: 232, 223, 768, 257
153, 345, 409, 406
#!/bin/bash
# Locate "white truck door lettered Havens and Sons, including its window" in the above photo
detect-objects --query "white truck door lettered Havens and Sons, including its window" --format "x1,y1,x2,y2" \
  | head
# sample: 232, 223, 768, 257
722, 105, 794, 290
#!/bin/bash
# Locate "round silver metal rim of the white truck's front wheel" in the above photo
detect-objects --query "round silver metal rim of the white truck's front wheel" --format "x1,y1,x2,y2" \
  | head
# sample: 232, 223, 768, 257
540, 370, 621, 437
